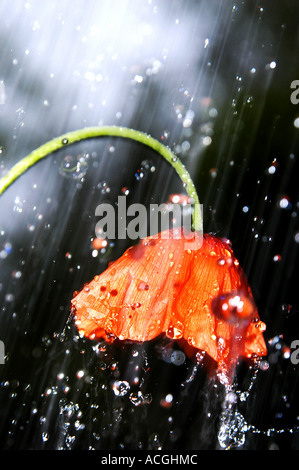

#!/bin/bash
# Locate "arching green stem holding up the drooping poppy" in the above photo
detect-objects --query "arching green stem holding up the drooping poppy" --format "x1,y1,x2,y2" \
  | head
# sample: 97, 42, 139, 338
0, 126, 203, 231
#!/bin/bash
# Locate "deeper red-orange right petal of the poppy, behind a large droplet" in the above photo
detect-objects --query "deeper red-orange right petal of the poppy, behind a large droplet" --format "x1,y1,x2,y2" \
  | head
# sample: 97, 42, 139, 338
175, 235, 266, 365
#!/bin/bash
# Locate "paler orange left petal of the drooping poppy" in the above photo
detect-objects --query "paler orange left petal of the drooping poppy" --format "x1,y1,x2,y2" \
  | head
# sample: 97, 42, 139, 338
72, 232, 195, 341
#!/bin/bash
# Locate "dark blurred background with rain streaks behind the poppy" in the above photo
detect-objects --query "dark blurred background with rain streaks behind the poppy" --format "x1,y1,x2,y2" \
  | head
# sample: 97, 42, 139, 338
0, 0, 299, 451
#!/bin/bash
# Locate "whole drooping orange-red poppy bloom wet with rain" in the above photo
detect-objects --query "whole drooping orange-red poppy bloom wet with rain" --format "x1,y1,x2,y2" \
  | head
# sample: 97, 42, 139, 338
71, 229, 267, 382
